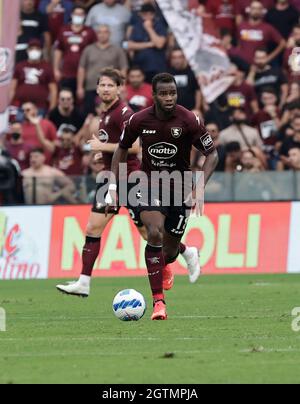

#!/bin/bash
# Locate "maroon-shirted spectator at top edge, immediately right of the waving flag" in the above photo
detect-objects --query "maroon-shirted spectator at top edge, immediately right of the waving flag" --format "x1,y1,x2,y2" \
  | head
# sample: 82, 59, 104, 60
206, 0, 236, 35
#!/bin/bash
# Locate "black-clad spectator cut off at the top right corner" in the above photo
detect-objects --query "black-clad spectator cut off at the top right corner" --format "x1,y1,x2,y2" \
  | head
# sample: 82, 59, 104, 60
265, 0, 299, 40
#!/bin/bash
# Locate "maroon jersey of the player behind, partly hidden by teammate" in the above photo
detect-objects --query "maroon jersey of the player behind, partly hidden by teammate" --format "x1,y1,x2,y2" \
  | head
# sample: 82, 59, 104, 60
99, 100, 141, 173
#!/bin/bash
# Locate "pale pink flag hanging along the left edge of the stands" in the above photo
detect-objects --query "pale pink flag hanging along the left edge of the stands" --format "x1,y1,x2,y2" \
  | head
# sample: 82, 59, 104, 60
0, 0, 20, 134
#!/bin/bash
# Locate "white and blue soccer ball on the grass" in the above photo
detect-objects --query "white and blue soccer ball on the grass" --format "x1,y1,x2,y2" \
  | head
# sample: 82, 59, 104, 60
113, 289, 146, 321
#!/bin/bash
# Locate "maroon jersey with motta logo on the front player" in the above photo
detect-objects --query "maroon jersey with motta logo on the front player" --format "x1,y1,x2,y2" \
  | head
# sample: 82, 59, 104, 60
120, 105, 215, 176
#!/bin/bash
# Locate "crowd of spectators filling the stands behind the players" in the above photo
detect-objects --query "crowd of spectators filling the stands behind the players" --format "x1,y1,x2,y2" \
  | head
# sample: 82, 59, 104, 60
0, 0, 300, 203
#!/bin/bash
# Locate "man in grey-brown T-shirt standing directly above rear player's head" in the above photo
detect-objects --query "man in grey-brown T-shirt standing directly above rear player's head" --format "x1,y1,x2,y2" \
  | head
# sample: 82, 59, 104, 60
77, 25, 128, 114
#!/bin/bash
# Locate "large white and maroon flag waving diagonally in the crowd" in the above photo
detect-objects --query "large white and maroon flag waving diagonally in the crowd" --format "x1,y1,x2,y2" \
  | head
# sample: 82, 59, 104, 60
157, 0, 234, 103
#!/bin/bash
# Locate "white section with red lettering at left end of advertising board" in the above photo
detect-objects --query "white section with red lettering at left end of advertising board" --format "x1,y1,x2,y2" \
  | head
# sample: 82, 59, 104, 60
0, 207, 52, 279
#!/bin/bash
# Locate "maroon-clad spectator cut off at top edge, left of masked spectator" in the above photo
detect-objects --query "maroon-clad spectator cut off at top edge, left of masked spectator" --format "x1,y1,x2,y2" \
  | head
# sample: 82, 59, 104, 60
39, 0, 74, 43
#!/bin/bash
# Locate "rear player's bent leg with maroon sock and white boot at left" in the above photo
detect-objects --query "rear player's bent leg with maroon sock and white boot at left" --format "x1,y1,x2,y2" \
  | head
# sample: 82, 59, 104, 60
57, 210, 114, 297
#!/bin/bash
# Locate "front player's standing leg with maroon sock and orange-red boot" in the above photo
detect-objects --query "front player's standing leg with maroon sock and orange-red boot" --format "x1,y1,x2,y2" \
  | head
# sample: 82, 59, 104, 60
141, 211, 167, 320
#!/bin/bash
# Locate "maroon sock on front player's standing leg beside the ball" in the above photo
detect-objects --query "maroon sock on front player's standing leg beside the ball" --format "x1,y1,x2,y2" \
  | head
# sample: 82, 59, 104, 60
145, 244, 165, 300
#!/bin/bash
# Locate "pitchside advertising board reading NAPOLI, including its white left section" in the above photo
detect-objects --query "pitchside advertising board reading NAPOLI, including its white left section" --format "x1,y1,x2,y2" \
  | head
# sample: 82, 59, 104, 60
0, 202, 300, 280
